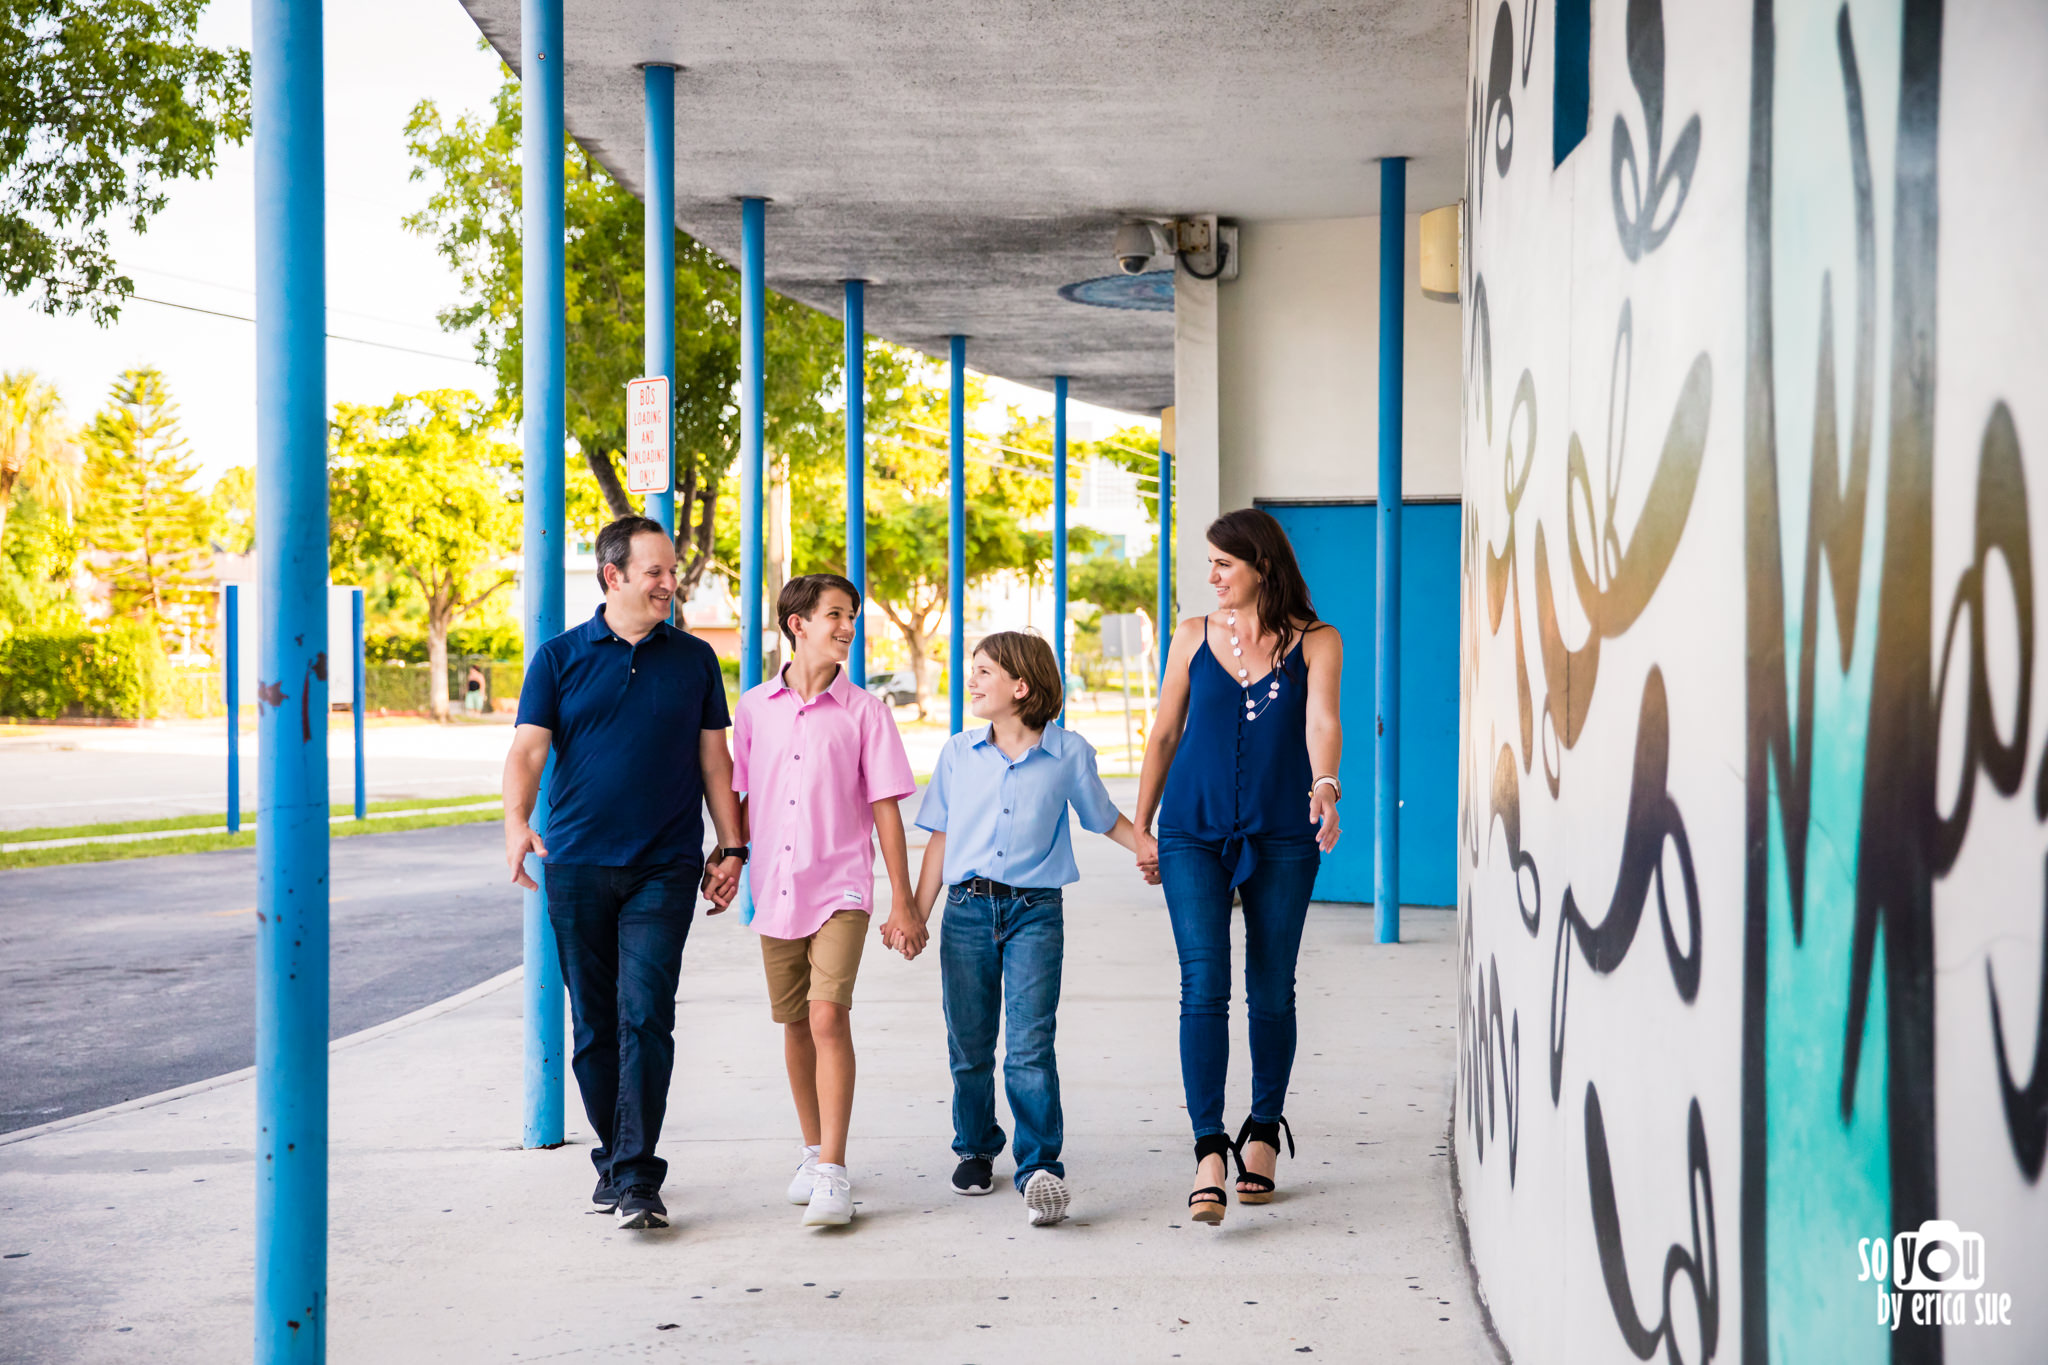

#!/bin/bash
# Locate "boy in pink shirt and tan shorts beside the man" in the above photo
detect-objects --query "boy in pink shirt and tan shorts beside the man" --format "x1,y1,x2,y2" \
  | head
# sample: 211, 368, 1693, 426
733, 573, 924, 1228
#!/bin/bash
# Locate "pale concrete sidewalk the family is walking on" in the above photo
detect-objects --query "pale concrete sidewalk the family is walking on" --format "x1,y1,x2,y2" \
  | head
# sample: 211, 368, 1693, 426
0, 818, 1497, 1365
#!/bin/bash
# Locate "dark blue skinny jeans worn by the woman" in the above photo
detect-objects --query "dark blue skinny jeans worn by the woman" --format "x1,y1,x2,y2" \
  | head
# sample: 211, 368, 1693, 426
1159, 831, 1323, 1138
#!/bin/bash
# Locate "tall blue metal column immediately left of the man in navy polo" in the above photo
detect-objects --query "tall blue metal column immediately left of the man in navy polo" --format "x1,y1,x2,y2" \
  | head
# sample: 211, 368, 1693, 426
520, 0, 569, 1148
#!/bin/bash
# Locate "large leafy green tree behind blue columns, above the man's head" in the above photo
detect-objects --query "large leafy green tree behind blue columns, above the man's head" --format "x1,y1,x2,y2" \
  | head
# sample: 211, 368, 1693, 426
406, 76, 844, 591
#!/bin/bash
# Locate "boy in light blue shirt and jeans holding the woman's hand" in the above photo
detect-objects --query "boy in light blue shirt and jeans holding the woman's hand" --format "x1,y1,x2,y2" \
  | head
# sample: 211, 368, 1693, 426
891, 630, 1137, 1228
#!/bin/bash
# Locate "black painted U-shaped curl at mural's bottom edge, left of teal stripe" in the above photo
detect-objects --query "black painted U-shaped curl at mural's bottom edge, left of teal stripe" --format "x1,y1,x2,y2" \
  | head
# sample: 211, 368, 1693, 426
1585, 1083, 1720, 1365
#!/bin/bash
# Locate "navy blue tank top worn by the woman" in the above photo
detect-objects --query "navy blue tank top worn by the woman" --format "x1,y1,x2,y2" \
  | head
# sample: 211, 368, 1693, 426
1159, 626, 1317, 886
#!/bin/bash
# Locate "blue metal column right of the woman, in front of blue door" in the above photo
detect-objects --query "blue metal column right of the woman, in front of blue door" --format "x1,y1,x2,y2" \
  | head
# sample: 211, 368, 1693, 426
1372, 156, 1407, 943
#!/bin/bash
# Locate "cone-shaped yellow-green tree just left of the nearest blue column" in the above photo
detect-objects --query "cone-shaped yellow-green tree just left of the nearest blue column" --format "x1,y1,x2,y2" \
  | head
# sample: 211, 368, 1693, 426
80, 366, 213, 632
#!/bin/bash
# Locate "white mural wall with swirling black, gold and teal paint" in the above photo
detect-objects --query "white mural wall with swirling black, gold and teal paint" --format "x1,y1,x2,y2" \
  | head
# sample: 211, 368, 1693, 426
1456, 0, 2048, 1365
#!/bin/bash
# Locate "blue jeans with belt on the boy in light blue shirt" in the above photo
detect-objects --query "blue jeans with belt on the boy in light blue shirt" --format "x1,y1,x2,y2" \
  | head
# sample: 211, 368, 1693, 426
938, 884, 1067, 1189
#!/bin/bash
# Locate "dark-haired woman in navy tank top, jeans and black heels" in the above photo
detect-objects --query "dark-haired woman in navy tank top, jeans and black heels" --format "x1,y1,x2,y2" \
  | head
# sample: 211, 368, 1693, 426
1137, 510, 1343, 1224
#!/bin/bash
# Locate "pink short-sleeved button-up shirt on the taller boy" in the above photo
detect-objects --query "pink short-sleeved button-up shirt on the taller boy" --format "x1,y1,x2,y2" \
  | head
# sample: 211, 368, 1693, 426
733, 667, 918, 939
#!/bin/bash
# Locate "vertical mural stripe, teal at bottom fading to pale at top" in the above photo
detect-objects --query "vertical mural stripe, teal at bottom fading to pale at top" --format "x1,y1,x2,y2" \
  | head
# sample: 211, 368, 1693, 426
1763, 0, 1901, 1365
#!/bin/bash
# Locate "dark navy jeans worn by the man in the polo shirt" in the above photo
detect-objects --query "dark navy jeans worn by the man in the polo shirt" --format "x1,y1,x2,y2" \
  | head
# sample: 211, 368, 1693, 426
545, 862, 702, 1189
